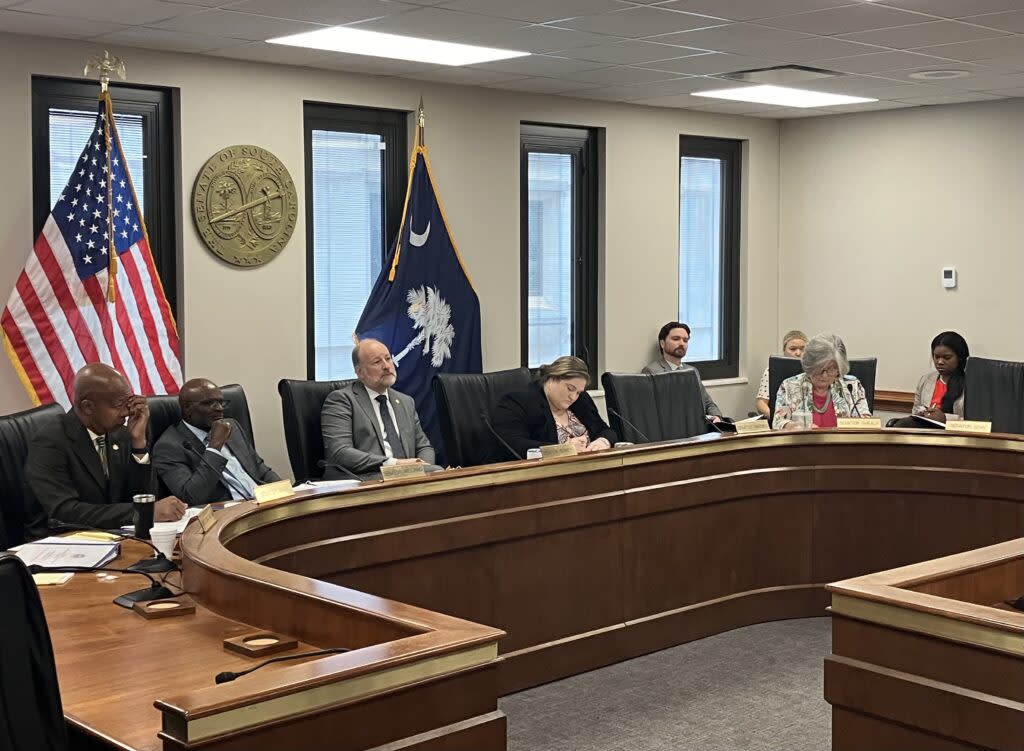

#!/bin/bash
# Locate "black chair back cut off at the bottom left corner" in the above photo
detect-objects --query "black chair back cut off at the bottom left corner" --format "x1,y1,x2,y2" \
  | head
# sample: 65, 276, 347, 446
0, 549, 68, 751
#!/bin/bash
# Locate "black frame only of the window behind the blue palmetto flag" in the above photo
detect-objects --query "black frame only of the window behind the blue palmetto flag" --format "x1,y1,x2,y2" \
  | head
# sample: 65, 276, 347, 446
302, 101, 411, 380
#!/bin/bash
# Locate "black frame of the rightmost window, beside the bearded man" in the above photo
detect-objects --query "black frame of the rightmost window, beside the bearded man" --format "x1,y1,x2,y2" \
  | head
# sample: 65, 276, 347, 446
676, 135, 743, 380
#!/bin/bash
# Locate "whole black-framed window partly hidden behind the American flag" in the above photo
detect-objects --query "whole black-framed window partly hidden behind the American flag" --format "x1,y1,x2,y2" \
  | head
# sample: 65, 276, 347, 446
32, 76, 180, 314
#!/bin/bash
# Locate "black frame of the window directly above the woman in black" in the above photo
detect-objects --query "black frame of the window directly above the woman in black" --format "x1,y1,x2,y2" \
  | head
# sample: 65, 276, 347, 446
519, 122, 600, 387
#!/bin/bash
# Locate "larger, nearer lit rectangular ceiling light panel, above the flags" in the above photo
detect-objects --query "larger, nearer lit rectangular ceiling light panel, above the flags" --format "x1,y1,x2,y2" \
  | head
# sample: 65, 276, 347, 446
266, 26, 529, 66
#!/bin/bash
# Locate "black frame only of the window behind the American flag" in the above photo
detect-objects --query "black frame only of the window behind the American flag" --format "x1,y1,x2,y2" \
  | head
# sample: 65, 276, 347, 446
32, 76, 182, 319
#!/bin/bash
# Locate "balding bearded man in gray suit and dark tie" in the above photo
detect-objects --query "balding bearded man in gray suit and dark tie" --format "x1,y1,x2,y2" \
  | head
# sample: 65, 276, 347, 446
321, 339, 437, 479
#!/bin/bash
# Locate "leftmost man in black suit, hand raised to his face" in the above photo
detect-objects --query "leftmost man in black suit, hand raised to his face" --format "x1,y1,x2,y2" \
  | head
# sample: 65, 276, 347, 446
25, 363, 185, 538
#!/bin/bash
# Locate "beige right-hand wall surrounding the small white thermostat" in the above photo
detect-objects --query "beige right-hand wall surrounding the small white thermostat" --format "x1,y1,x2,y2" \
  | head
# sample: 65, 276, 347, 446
779, 99, 1024, 390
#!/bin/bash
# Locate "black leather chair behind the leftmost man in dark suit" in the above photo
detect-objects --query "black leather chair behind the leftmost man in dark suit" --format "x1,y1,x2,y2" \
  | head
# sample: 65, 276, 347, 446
0, 404, 63, 549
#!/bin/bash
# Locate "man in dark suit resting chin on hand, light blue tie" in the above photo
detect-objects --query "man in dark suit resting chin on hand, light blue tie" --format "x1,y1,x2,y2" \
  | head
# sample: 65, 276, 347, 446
153, 378, 281, 506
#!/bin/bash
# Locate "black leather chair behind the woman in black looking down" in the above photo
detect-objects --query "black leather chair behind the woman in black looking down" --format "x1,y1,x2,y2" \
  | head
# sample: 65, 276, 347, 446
432, 368, 530, 467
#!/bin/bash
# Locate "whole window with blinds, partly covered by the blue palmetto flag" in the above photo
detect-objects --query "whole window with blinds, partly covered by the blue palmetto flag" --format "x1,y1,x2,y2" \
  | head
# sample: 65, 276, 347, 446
305, 102, 409, 380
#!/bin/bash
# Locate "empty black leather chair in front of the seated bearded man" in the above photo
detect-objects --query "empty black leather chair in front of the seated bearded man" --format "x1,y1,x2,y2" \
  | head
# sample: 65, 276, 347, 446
601, 371, 708, 444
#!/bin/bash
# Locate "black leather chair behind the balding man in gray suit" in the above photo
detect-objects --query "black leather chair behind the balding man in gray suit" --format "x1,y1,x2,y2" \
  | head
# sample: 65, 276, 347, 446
278, 378, 354, 483
